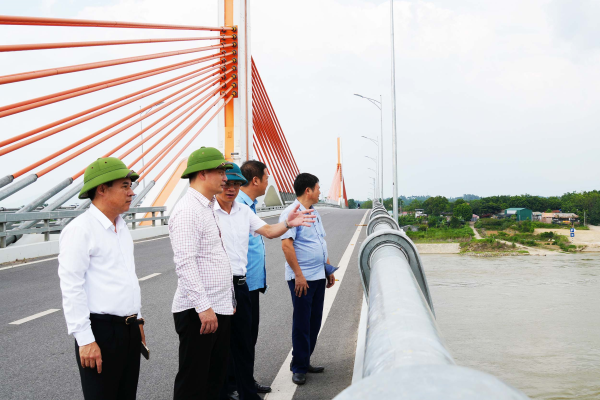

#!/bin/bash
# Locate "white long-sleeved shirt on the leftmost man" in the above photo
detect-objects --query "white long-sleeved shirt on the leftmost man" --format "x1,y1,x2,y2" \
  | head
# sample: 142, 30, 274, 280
58, 204, 142, 346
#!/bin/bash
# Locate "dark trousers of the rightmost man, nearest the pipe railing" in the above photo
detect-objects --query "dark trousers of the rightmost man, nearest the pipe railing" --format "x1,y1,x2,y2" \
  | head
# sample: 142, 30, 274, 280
288, 279, 326, 374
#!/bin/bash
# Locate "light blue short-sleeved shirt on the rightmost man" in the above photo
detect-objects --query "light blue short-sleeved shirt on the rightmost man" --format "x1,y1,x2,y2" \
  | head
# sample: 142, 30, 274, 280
279, 200, 328, 281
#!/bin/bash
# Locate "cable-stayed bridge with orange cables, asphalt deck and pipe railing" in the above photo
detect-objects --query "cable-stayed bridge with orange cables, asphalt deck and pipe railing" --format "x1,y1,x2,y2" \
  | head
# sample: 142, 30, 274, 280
0, 0, 524, 400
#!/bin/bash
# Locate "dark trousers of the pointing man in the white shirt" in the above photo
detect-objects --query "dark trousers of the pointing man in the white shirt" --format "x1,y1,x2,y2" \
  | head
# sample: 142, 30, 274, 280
221, 282, 260, 400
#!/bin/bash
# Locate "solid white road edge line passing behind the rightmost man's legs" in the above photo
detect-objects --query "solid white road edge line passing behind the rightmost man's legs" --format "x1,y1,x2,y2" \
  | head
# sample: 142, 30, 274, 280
265, 211, 368, 400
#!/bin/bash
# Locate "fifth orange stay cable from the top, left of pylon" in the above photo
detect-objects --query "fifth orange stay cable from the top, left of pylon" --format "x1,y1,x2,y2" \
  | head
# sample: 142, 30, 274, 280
0, 57, 227, 156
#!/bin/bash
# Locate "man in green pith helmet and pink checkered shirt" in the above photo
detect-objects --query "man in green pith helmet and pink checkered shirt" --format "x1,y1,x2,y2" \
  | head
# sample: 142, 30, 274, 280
169, 147, 236, 400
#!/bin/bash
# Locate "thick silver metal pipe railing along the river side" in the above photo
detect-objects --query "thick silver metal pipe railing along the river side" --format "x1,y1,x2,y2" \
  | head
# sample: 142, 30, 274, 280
335, 204, 528, 400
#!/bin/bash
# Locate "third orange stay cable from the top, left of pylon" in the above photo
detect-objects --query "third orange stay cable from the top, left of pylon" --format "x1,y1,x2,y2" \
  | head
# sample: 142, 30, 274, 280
0, 43, 235, 85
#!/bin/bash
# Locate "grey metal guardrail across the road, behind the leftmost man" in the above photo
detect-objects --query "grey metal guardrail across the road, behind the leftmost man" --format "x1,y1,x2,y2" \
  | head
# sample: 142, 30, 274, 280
0, 207, 169, 248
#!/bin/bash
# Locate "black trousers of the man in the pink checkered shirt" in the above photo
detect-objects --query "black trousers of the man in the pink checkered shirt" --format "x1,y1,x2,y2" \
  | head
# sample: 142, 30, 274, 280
173, 308, 231, 400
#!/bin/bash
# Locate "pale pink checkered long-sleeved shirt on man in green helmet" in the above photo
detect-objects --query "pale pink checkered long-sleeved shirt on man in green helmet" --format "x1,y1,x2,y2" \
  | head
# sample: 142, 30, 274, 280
169, 187, 235, 315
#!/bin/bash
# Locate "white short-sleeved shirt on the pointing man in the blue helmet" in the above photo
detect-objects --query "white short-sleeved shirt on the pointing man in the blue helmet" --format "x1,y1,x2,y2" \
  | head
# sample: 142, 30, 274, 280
215, 201, 267, 276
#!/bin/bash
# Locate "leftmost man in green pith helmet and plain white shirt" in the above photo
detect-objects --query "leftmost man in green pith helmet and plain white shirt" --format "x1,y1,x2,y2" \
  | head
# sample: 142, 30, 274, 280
58, 157, 146, 400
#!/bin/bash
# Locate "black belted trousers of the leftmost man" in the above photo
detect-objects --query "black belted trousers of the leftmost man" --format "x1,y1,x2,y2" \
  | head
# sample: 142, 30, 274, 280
75, 314, 142, 400
